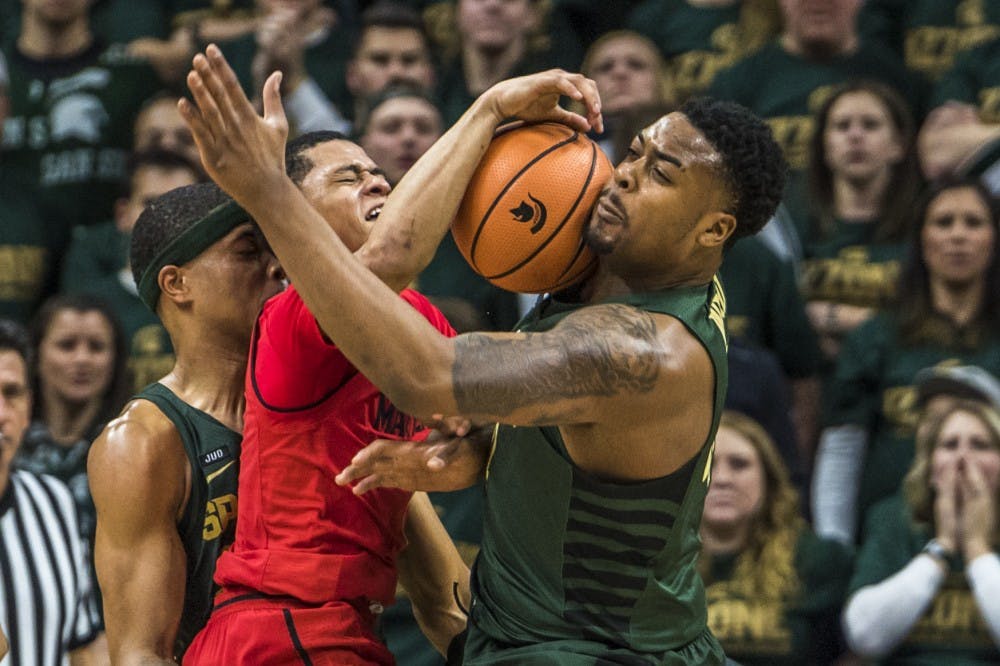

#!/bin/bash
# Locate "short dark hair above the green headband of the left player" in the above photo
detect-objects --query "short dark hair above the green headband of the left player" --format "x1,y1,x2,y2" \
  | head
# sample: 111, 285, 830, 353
129, 182, 232, 284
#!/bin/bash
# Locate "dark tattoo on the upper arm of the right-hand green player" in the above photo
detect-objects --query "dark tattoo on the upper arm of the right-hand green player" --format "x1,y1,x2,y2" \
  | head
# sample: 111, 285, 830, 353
452, 305, 663, 420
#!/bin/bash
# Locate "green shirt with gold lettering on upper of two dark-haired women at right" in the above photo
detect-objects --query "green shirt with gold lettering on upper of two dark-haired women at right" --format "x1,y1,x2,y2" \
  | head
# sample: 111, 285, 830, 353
800, 219, 907, 308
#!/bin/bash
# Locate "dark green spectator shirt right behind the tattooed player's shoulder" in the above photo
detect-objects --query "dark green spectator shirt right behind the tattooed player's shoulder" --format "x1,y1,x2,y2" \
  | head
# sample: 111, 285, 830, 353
719, 237, 822, 379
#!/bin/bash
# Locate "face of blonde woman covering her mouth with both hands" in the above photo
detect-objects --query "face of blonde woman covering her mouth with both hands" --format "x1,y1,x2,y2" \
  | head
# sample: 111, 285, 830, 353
931, 409, 1000, 495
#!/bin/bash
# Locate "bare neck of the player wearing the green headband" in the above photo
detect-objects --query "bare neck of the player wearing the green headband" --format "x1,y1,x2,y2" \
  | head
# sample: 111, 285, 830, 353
161, 342, 249, 430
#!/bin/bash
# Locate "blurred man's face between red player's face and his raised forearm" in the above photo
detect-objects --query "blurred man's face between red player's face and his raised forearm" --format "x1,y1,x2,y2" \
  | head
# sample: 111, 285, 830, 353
361, 97, 441, 185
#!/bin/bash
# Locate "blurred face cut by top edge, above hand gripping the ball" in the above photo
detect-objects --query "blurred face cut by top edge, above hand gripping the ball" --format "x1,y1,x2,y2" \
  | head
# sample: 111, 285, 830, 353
458, 0, 538, 53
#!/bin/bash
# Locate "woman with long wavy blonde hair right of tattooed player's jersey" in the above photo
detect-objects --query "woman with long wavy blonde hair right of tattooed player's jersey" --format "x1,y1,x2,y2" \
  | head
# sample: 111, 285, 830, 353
699, 411, 850, 666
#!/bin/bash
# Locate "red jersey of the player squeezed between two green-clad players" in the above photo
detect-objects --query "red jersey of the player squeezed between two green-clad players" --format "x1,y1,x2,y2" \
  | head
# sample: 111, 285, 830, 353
215, 287, 455, 605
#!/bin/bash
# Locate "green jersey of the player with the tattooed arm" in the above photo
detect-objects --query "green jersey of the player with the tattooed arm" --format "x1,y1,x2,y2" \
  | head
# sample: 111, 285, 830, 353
465, 280, 728, 666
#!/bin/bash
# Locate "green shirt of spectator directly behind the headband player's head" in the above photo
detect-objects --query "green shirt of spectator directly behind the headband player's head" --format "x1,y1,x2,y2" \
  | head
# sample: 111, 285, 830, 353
61, 221, 174, 393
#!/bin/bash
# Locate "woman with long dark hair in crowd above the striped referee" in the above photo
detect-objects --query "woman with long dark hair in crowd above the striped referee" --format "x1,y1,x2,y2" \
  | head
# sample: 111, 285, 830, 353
14, 294, 128, 544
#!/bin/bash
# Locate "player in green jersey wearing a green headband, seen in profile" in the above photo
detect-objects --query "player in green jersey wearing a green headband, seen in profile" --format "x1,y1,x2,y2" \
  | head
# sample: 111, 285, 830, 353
88, 183, 284, 663
